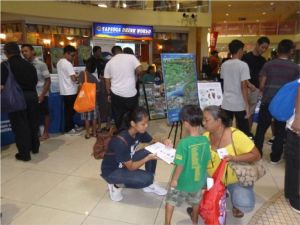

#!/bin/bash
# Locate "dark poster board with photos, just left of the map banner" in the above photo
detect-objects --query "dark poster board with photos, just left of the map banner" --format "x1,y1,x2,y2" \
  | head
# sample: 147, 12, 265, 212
139, 83, 167, 120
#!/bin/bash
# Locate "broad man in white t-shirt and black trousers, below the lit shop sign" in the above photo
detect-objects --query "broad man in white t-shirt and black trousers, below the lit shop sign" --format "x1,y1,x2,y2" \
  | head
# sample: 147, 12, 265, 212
104, 46, 142, 128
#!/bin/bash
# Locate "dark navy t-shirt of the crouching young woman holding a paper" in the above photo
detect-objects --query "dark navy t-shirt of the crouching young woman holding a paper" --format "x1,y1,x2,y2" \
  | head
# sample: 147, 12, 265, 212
101, 130, 152, 177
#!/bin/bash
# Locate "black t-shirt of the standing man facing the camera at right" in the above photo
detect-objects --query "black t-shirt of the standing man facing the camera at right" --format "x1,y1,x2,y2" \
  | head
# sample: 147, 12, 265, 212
242, 52, 266, 88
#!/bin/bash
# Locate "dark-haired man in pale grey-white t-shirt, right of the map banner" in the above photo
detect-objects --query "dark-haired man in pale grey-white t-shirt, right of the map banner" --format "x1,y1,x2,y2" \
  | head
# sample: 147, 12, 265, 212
221, 40, 252, 136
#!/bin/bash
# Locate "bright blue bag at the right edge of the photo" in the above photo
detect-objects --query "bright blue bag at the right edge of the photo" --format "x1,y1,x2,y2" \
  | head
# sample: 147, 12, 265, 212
269, 79, 300, 121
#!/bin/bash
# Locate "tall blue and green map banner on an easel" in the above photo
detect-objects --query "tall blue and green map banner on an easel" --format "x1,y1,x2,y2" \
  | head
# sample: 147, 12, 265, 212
161, 53, 199, 123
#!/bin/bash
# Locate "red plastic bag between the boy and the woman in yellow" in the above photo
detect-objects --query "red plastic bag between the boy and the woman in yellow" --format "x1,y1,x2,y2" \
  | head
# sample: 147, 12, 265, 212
199, 160, 227, 225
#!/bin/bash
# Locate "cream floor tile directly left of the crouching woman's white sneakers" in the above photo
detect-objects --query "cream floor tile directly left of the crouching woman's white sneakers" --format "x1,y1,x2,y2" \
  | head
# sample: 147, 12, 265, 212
36, 176, 107, 214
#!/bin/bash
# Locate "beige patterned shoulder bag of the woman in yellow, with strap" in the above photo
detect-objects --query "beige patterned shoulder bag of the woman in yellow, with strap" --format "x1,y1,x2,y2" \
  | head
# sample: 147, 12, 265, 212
229, 131, 266, 187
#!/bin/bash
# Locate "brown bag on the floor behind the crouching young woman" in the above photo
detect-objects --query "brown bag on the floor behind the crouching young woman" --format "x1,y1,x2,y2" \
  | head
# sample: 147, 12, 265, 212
91, 129, 128, 159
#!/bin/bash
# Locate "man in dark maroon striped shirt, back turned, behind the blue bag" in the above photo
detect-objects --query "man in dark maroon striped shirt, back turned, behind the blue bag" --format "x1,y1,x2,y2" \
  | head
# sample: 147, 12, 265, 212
255, 40, 299, 164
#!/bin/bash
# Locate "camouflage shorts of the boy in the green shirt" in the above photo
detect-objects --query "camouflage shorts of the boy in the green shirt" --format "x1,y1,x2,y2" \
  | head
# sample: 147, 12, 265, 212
166, 188, 202, 207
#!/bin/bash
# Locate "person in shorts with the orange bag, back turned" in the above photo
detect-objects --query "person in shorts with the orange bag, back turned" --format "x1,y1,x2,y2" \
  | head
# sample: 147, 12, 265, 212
79, 58, 99, 139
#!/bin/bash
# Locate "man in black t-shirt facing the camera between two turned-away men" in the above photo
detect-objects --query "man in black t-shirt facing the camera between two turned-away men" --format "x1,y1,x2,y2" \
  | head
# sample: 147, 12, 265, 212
242, 37, 270, 129
